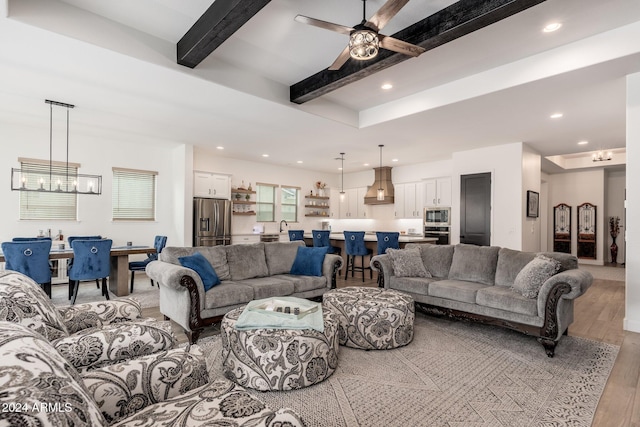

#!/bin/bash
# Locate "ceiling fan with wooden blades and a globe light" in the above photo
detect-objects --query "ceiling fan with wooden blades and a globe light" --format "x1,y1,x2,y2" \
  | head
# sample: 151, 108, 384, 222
295, 0, 425, 70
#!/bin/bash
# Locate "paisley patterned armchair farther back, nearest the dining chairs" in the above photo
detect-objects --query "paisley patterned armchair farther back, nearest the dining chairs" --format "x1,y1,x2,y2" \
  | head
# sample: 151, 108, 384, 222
0, 271, 176, 372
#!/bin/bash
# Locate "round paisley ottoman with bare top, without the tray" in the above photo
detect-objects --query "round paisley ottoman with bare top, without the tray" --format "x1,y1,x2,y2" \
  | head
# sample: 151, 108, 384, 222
322, 287, 415, 350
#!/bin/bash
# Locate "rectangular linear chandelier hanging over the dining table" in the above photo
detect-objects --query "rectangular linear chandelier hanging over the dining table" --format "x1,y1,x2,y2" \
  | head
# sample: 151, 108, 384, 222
11, 99, 102, 195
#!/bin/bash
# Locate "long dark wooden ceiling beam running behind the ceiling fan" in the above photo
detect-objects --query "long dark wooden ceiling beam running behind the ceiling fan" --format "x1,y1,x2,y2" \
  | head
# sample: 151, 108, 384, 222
289, 0, 545, 104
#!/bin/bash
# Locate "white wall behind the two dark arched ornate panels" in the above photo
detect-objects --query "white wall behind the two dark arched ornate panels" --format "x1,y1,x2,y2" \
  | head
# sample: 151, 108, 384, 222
548, 169, 609, 265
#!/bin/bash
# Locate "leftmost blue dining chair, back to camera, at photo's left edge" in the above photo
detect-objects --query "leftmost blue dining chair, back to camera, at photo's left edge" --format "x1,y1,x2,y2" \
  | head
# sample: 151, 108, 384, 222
2, 239, 51, 298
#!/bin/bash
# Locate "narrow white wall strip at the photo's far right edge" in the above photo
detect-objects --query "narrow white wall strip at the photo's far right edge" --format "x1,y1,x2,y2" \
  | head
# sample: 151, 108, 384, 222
624, 73, 640, 332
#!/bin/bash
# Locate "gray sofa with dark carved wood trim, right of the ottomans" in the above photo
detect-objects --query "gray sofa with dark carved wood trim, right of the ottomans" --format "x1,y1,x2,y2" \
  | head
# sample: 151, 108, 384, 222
371, 244, 593, 357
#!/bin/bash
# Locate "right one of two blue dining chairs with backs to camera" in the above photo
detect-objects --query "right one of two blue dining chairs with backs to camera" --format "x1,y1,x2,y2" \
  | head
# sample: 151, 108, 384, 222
69, 239, 113, 305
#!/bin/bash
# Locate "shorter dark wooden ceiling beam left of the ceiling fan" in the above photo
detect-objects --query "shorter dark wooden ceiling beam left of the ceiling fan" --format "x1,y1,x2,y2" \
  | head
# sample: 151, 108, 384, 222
177, 0, 271, 68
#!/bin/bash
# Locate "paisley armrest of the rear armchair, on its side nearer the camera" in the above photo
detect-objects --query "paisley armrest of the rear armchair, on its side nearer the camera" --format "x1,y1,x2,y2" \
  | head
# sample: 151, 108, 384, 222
51, 319, 177, 373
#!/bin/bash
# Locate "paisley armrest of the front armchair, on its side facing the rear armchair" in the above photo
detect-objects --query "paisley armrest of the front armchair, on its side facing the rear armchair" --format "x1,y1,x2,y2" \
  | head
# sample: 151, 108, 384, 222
82, 345, 209, 424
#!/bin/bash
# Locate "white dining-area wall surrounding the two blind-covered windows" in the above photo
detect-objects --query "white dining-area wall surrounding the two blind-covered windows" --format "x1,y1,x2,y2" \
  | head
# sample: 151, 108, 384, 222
0, 120, 191, 246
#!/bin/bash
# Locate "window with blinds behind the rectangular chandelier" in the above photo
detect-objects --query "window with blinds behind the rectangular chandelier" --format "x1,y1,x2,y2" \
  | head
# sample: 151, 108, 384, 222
20, 159, 79, 221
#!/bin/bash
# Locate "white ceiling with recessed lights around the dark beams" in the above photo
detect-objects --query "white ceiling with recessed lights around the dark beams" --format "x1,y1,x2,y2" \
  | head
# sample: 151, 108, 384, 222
0, 0, 640, 172
